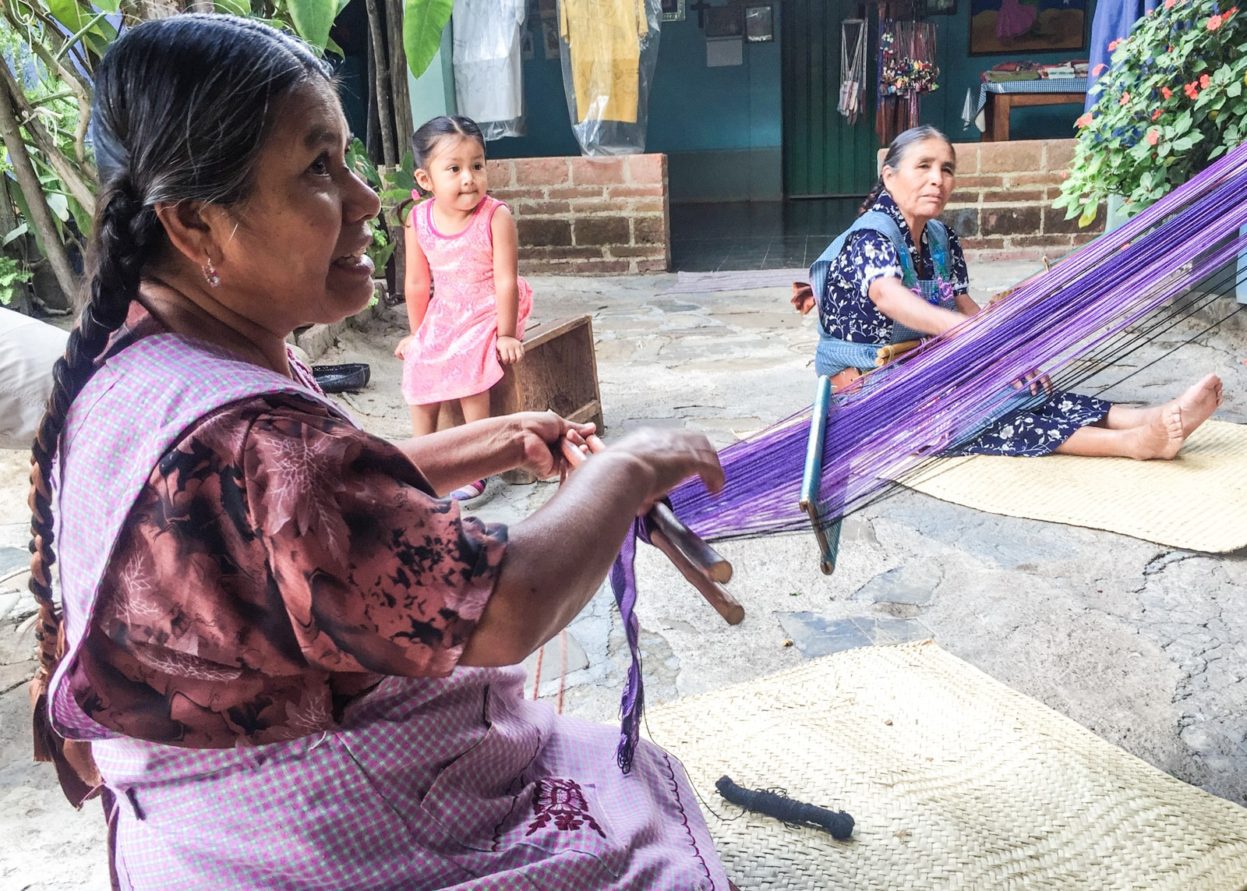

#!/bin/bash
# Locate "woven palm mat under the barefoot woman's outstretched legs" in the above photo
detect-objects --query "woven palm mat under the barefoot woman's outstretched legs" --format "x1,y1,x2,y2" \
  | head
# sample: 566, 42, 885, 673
902, 421, 1247, 553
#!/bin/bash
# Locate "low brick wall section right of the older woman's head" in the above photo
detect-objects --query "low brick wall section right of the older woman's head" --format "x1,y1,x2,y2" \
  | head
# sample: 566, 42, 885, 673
940, 140, 1104, 263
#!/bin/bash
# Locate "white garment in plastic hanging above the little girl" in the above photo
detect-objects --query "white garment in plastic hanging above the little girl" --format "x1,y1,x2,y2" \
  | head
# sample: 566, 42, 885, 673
451, 0, 527, 140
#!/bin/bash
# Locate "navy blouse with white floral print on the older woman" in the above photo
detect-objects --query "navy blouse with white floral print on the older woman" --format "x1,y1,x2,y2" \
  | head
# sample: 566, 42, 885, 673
818, 192, 970, 344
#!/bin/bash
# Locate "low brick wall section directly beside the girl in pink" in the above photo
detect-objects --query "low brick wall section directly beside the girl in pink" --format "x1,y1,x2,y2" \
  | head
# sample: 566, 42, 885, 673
489, 155, 671, 275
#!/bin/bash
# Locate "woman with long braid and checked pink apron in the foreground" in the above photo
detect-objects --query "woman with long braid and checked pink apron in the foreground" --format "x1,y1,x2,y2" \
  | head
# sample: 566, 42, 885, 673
31, 15, 728, 889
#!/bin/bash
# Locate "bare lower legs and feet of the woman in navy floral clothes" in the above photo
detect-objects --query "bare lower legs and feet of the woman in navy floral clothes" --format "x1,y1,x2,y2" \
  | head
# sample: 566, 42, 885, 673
1056, 374, 1222, 460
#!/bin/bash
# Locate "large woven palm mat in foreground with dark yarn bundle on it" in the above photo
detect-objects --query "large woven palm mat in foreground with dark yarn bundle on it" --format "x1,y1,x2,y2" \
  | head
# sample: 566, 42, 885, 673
647, 641, 1247, 891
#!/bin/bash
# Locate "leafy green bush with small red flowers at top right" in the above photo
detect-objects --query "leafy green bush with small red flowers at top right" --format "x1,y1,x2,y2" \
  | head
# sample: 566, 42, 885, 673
1056, 0, 1247, 226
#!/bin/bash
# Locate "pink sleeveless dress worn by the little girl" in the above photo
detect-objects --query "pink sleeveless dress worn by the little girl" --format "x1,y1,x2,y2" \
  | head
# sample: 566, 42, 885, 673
403, 196, 532, 405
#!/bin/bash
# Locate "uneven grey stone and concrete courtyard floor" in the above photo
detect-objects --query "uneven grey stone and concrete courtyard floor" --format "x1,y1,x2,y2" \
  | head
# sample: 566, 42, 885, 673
0, 263, 1247, 889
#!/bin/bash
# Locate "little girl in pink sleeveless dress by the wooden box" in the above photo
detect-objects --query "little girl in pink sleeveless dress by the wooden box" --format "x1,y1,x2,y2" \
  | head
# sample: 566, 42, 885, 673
394, 116, 532, 501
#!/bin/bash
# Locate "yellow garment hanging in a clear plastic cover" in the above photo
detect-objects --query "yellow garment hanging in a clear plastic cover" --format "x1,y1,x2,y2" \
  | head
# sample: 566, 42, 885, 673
559, 0, 661, 156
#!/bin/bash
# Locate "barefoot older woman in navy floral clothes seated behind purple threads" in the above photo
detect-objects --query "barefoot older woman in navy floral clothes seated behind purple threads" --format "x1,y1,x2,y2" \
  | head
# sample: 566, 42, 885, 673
811, 126, 1221, 459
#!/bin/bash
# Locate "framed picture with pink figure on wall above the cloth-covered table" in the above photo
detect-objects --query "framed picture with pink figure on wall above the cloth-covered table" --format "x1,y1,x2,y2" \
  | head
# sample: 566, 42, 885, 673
969, 0, 1087, 56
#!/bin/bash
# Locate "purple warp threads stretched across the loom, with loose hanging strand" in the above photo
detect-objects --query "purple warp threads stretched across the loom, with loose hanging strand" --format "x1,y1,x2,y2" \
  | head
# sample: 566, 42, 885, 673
611, 145, 1247, 771
